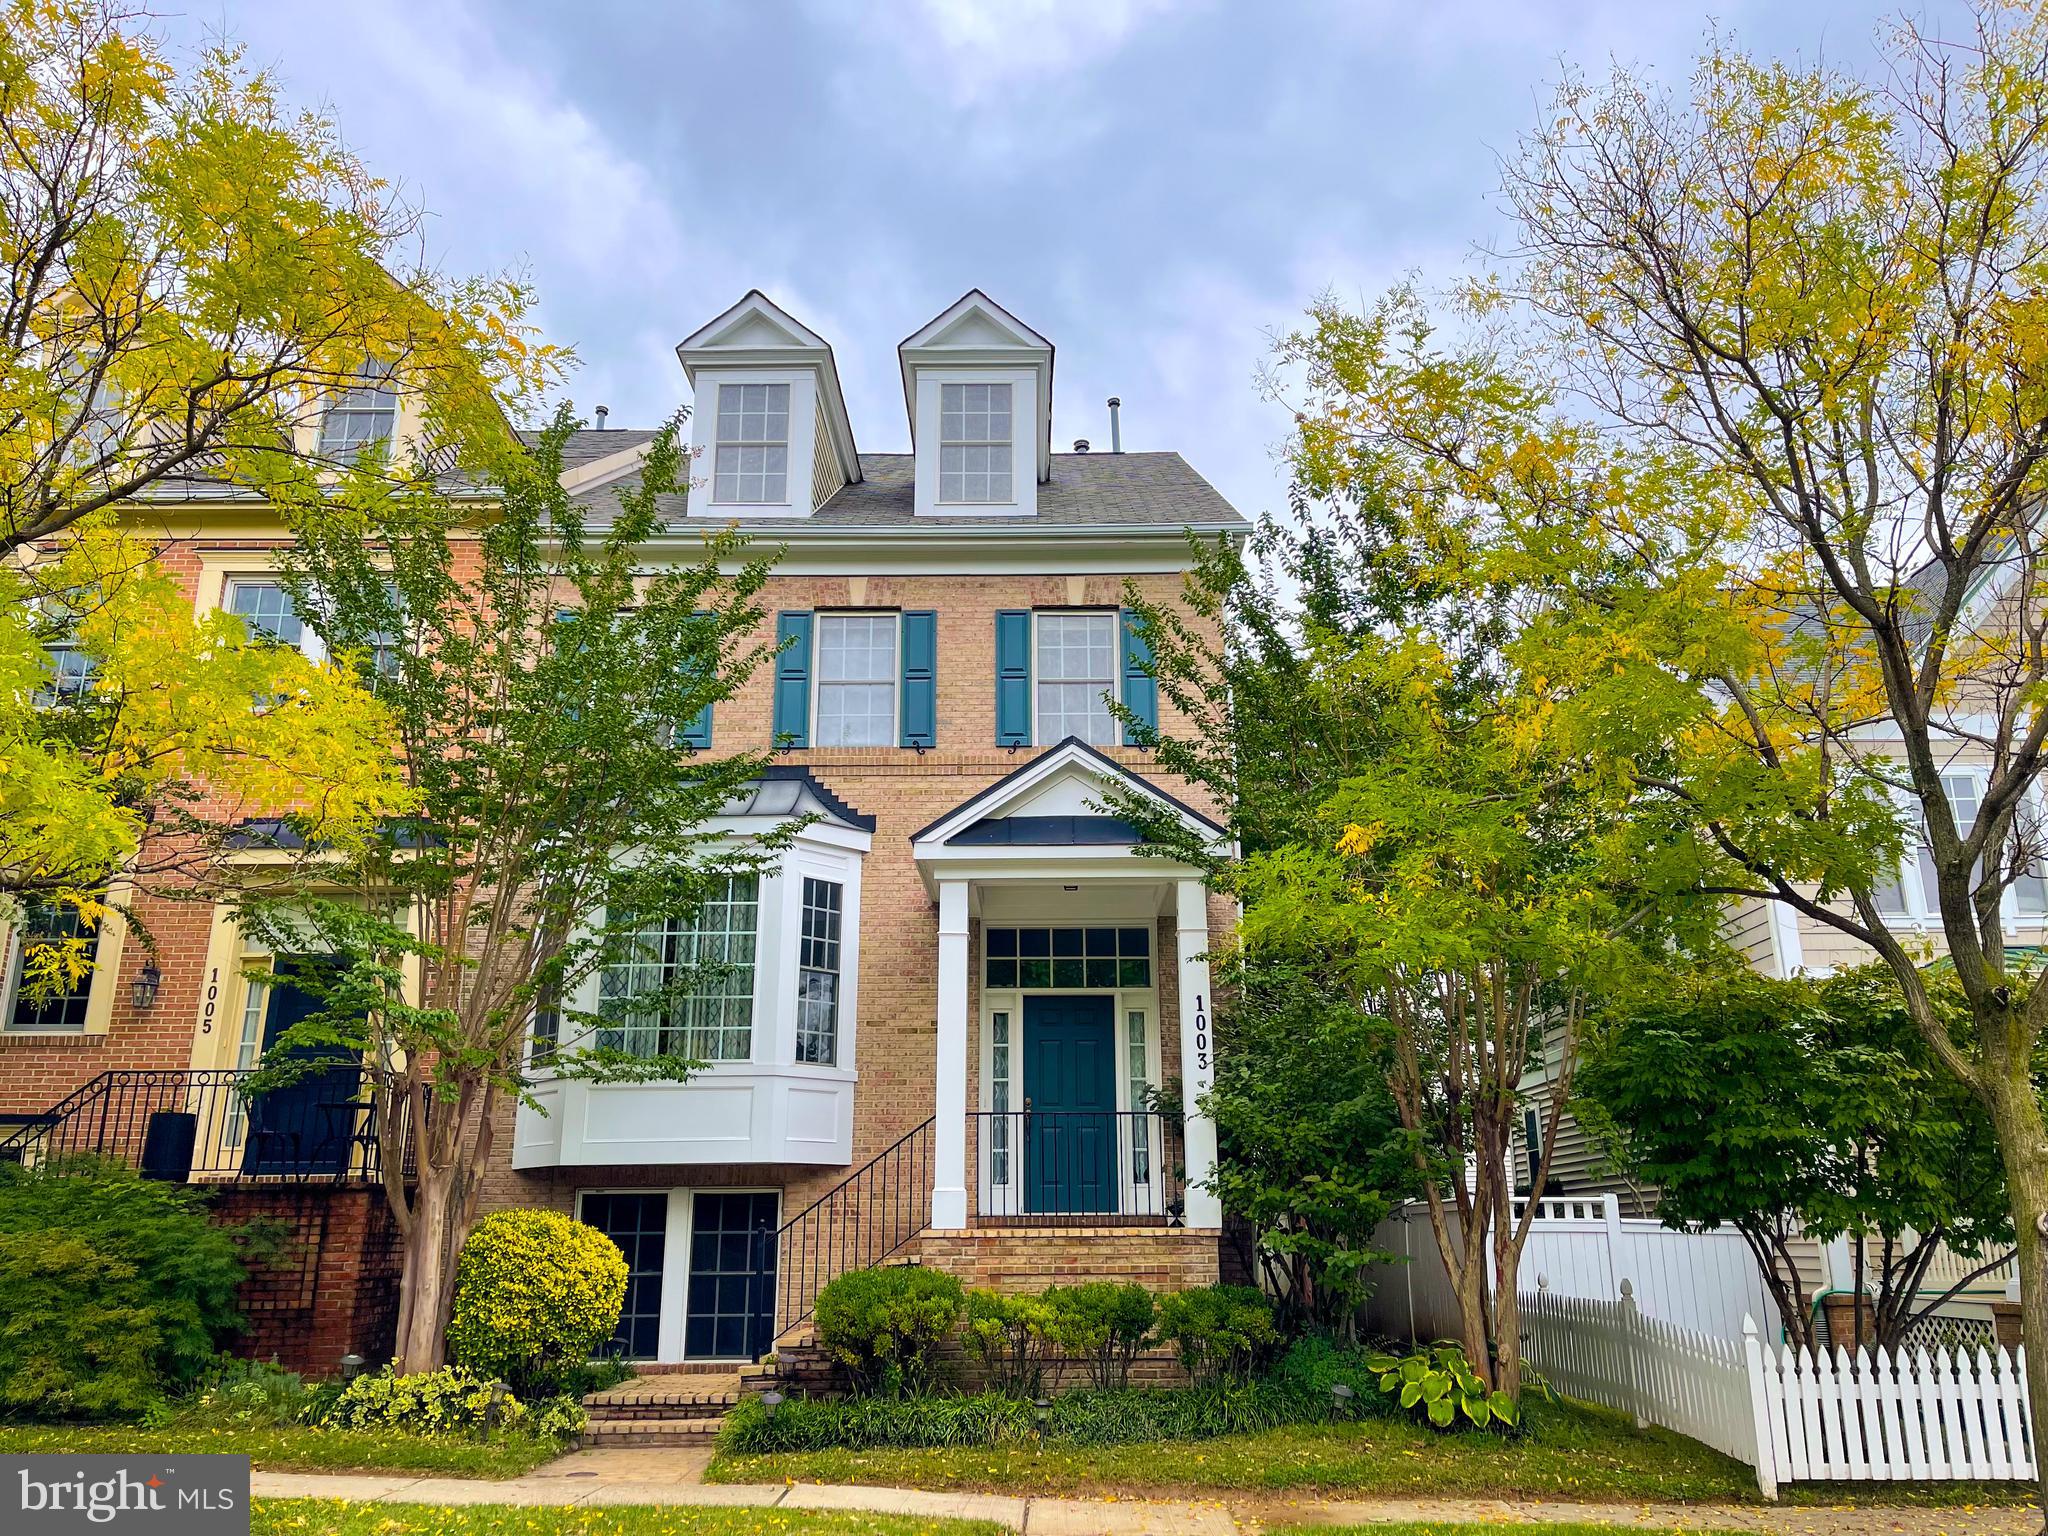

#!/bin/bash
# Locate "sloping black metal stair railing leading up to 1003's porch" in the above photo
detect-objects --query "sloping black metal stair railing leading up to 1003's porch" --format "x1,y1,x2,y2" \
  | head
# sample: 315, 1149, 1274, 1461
774, 1120, 932, 1333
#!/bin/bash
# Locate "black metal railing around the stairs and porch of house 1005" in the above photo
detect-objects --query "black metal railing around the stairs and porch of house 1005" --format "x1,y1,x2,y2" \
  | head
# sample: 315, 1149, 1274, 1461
0, 1063, 412, 1184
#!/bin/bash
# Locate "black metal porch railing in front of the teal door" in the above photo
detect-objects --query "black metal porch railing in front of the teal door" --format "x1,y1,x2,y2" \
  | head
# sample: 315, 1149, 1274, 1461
967, 1110, 1188, 1227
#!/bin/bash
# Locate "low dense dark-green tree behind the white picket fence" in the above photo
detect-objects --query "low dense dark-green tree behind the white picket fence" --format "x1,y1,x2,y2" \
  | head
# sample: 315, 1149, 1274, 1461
1579, 967, 2013, 1348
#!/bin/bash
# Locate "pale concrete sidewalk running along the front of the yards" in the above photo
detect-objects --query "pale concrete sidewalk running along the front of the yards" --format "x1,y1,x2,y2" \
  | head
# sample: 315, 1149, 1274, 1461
252, 1450, 2042, 1536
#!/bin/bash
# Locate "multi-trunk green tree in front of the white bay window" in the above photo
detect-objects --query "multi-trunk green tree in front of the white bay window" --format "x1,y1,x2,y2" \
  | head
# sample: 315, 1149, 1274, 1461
242, 412, 778, 1372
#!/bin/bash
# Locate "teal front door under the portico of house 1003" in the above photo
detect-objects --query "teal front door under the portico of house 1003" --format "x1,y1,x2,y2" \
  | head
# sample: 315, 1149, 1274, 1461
1024, 997, 1116, 1217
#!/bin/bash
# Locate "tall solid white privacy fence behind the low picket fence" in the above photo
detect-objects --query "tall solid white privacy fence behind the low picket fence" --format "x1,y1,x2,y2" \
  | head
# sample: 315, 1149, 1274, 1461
1366, 1194, 1778, 1341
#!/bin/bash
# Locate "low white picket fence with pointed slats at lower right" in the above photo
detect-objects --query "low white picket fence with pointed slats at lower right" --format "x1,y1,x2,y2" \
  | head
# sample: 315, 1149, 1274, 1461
1520, 1280, 2038, 1499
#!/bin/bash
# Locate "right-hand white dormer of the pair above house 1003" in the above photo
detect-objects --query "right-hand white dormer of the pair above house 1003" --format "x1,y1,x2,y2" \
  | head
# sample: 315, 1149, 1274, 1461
897, 289, 1053, 518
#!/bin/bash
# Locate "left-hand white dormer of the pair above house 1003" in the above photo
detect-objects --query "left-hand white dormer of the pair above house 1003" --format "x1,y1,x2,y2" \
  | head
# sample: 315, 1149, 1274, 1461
676, 289, 860, 518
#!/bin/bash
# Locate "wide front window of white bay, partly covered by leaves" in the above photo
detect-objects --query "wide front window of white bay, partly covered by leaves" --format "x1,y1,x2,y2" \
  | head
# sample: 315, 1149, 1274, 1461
598, 874, 760, 1061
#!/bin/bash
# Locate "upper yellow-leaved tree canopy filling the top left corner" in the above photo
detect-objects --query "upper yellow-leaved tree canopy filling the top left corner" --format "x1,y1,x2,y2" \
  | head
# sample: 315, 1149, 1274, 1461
0, 0, 563, 555
